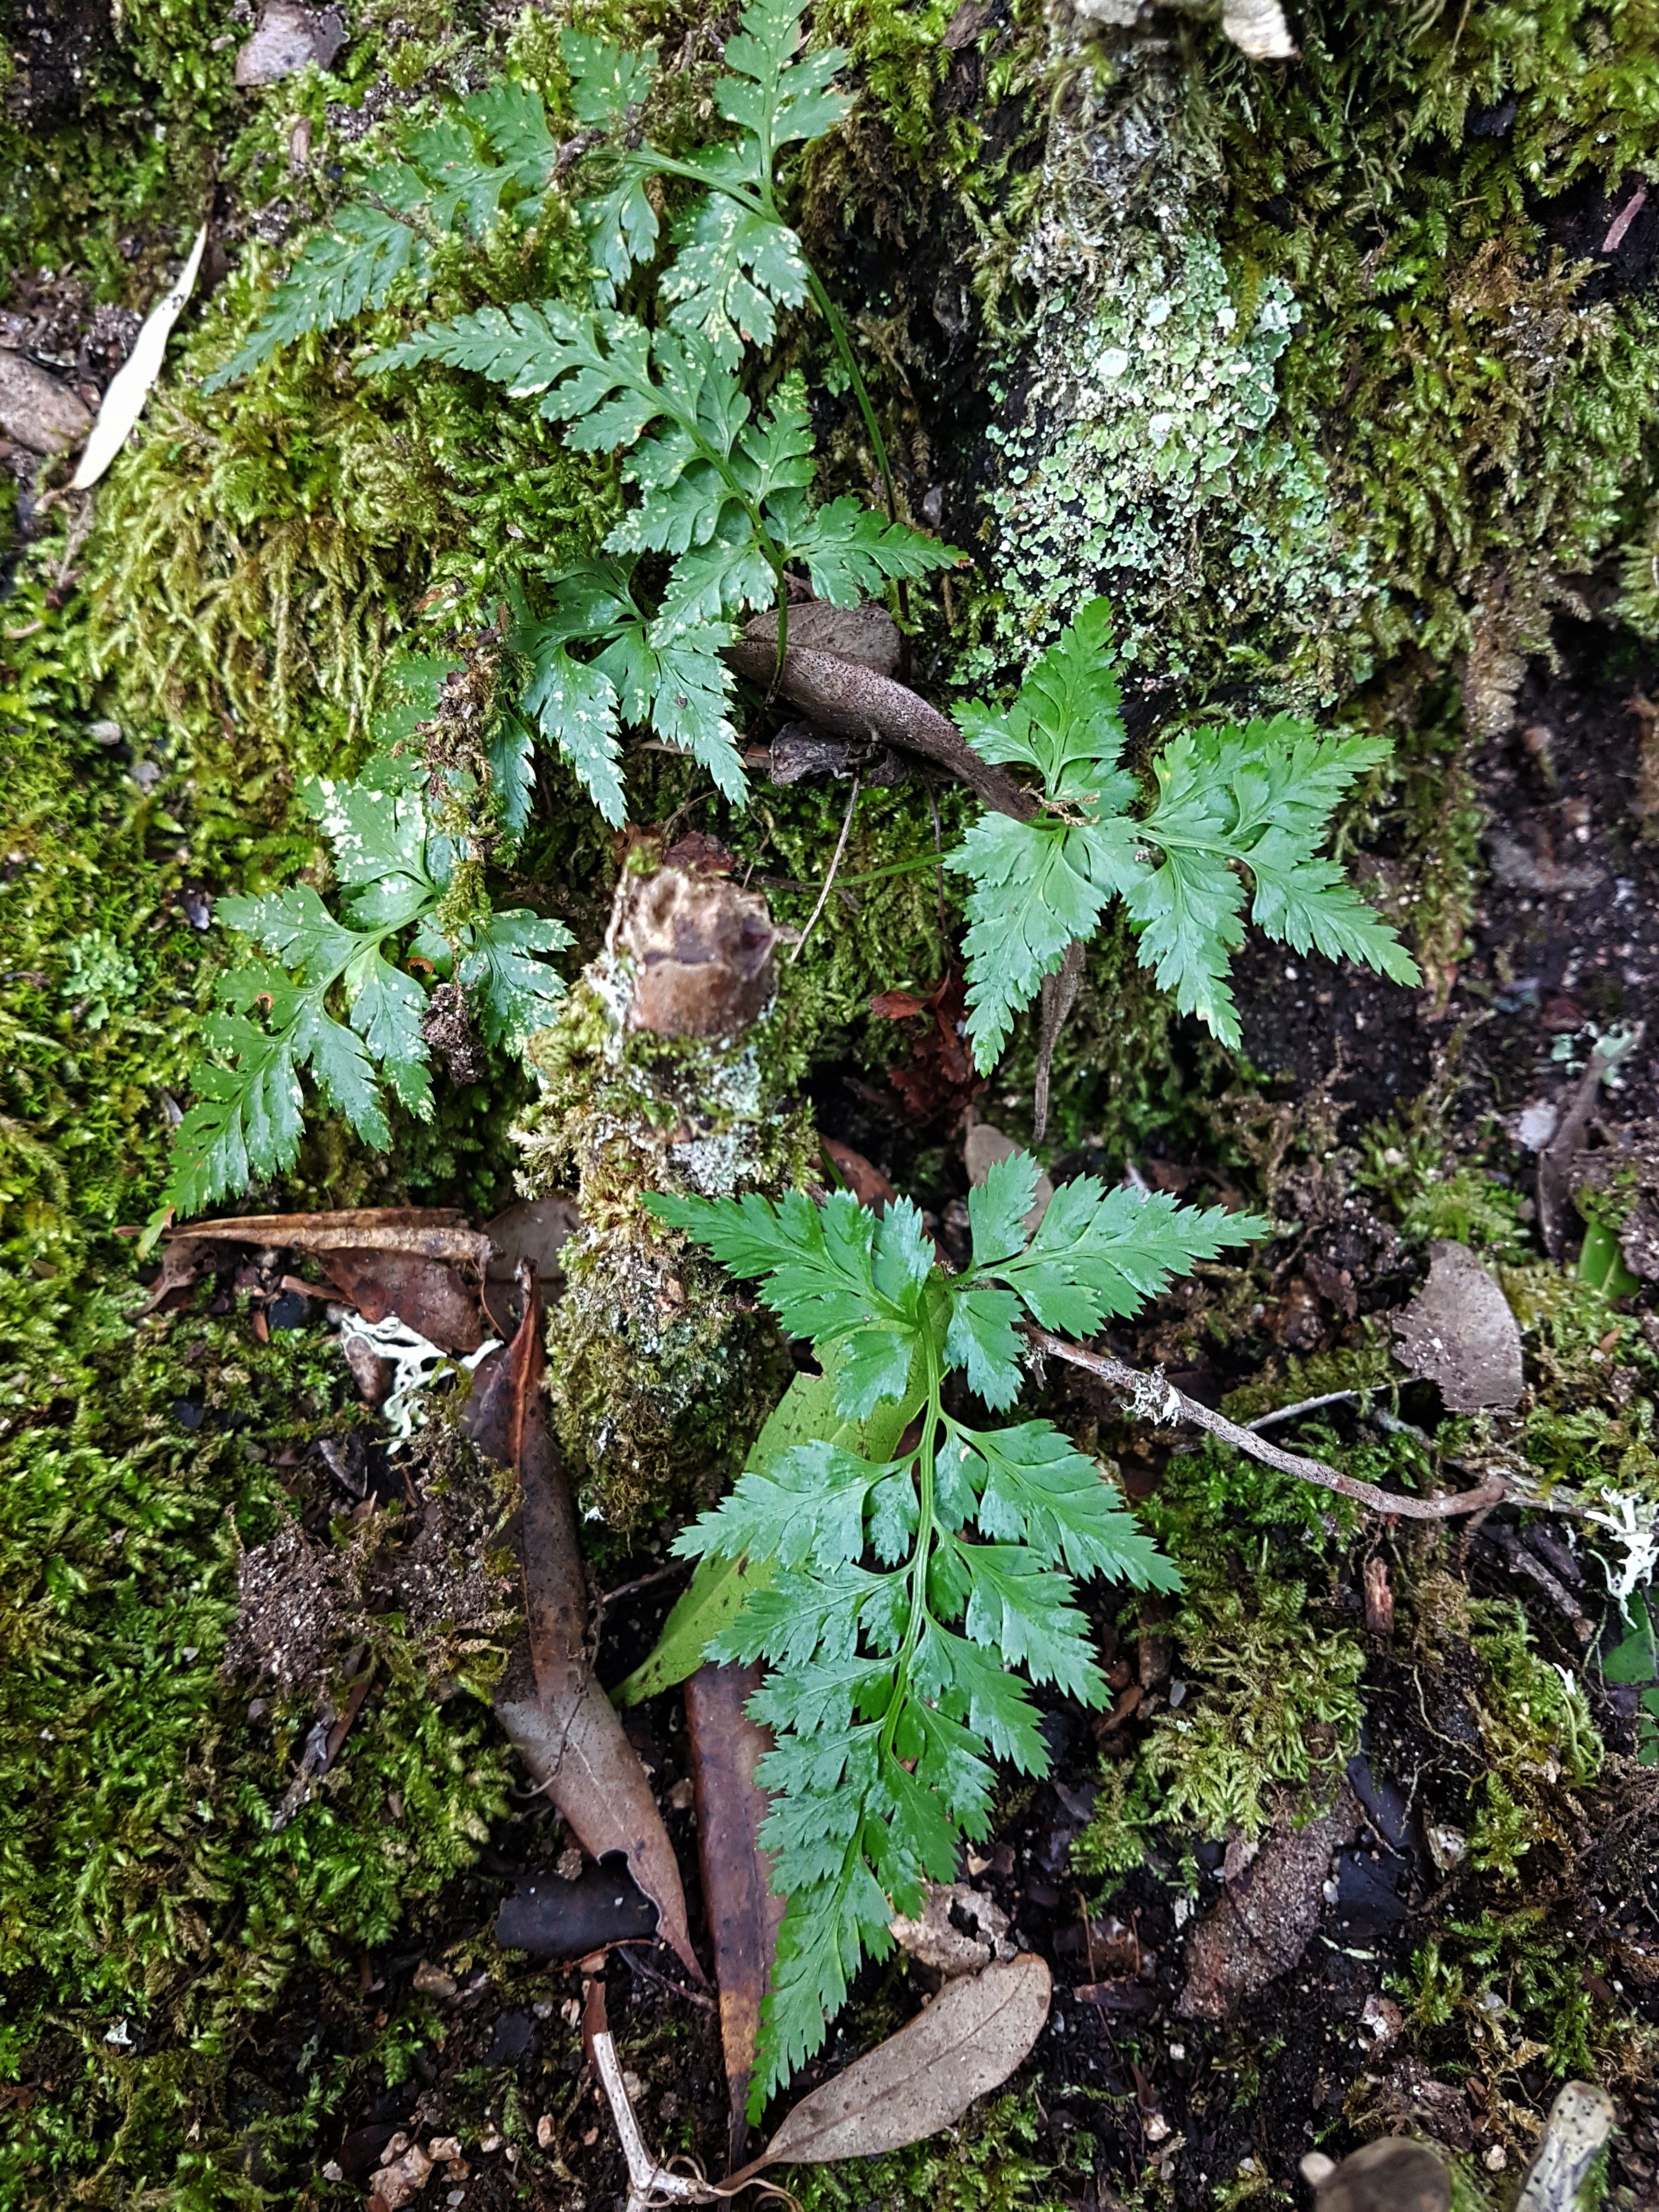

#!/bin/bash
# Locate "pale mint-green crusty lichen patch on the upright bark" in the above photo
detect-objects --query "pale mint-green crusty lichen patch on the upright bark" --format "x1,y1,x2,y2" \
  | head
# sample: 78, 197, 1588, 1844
964, 232, 1372, 699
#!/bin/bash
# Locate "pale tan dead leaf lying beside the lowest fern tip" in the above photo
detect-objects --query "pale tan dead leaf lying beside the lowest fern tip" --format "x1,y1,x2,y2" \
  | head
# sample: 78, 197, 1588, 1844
732, 1951, 1051, 2181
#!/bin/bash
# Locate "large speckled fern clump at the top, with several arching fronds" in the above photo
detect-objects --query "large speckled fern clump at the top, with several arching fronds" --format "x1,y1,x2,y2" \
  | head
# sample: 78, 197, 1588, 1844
210, 0, 942, 827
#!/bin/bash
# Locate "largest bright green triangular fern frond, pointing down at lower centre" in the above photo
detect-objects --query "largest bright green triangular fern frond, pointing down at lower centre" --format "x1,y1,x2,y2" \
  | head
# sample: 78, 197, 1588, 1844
648, 1155, 1265, 2117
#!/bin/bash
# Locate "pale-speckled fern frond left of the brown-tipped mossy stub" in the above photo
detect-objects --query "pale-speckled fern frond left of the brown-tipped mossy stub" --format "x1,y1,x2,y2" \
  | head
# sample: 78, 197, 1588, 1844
153, 662, 575, 1230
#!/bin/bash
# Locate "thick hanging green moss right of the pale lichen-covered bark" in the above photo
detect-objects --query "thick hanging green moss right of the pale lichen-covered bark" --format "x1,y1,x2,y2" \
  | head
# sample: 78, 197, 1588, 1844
1205, 0, 1659, 672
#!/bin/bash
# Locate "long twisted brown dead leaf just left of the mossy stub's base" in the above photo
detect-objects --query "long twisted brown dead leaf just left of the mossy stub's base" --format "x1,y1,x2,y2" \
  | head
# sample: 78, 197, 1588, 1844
467, 1265, 703, 1982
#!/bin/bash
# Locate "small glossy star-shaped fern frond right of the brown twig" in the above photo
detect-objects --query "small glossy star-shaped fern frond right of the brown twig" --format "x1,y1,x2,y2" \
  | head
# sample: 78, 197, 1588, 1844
945, 600, 1418, 1073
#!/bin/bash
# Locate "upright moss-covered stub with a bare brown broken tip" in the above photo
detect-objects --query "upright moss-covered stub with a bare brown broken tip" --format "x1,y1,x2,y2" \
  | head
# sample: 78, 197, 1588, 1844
515, 840, 812, 1531
